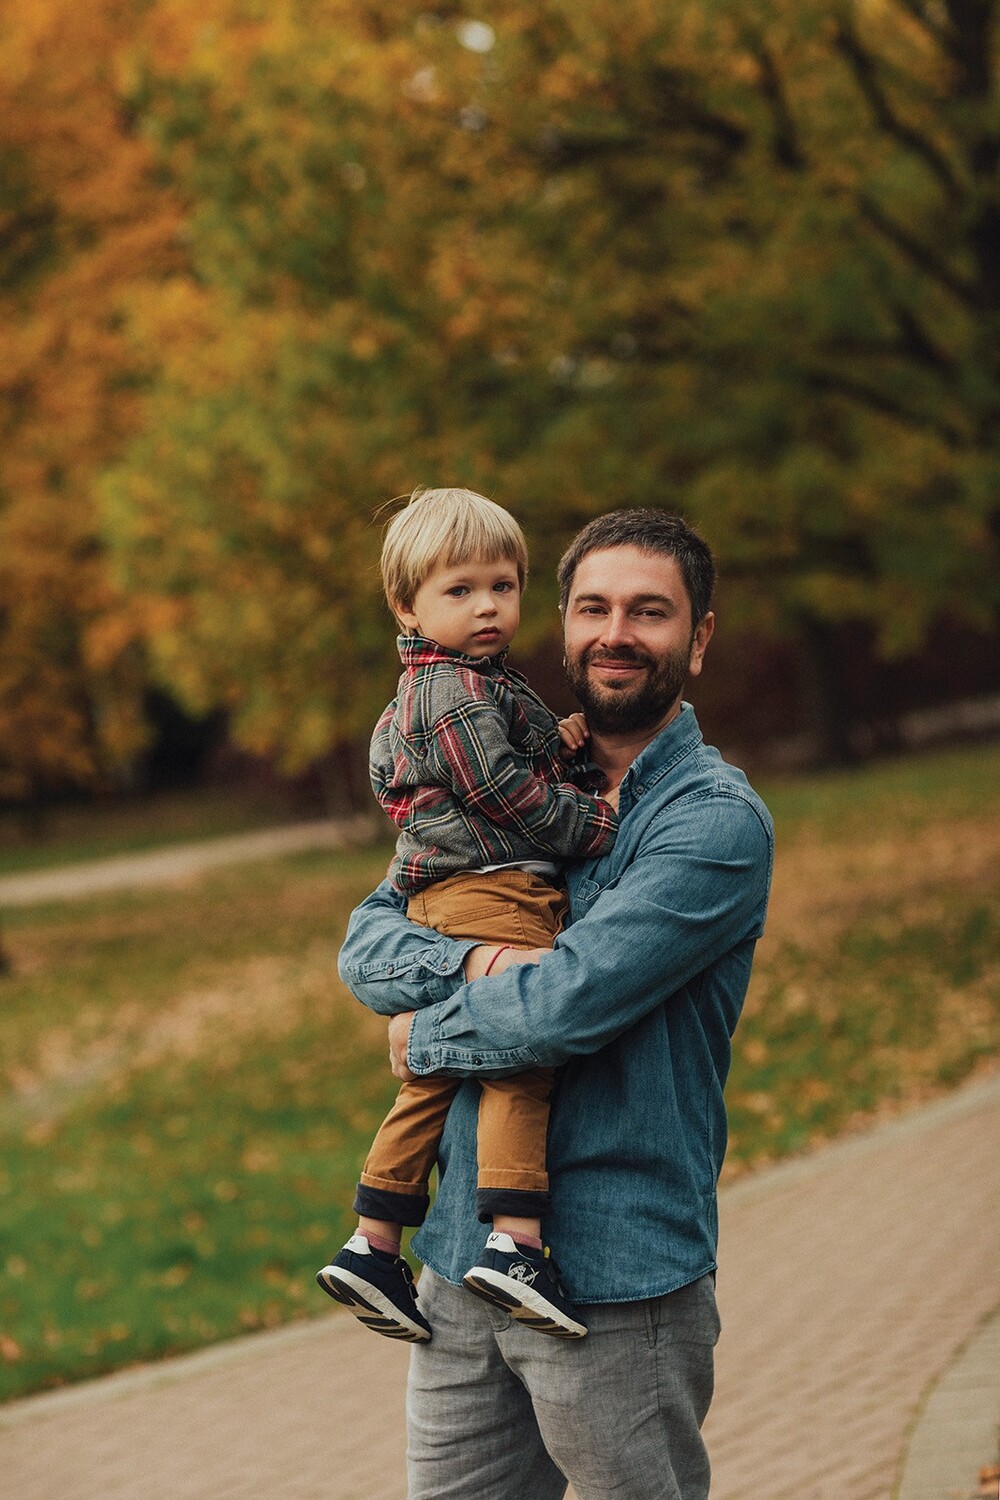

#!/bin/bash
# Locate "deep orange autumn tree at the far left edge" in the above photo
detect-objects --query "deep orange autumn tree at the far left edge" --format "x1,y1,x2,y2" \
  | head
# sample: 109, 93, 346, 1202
0, 0, 182, 798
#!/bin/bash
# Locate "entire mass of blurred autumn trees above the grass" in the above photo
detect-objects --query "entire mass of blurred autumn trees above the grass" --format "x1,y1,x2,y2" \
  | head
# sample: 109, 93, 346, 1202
0, 0, 1000, 812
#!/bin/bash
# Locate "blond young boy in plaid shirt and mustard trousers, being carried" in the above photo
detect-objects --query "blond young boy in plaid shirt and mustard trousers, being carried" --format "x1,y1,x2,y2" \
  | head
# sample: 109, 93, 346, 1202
316, 489, 618, 1341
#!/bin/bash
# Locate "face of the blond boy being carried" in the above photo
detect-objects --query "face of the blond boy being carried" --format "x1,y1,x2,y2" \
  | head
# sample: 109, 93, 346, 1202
396, 560, 520, 660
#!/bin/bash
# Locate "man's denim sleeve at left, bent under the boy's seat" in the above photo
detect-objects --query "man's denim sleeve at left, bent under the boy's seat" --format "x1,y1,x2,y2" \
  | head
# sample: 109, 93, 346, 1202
337, 881, 475, 1016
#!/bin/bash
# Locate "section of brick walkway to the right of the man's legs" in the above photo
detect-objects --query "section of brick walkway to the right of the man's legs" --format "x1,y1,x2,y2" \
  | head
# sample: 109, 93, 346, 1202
706, 1079, 1000, 1500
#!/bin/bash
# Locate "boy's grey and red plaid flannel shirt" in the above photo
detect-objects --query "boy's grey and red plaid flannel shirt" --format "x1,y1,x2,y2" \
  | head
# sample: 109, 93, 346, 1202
369, 636, 618, 896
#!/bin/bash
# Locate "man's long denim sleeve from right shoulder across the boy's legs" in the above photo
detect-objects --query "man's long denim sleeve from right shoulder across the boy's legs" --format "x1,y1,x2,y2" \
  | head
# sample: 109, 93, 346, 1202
408, 792, 772, 1076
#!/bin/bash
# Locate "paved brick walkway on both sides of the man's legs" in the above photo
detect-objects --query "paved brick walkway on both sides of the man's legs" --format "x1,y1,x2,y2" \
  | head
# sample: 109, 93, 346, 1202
0, 1076, 1000, 1500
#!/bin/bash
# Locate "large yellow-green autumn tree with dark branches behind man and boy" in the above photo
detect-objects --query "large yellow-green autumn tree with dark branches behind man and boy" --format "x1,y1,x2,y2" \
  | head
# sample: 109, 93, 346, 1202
105, 0, 1000, 764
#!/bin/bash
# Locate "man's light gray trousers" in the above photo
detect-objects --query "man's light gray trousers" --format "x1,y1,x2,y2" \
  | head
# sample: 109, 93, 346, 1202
406, 1269, 720, 1500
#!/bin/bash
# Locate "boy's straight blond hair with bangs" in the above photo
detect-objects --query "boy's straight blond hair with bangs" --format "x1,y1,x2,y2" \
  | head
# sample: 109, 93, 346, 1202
382, 489, 528, 618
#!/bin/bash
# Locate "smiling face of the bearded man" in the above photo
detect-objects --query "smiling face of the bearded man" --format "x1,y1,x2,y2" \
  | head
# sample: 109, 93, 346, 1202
564, 546, 714, 734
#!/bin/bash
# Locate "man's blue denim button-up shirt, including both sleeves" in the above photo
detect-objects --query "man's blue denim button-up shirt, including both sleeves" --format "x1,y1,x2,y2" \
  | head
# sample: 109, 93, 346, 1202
340, 704, 774, 1304
